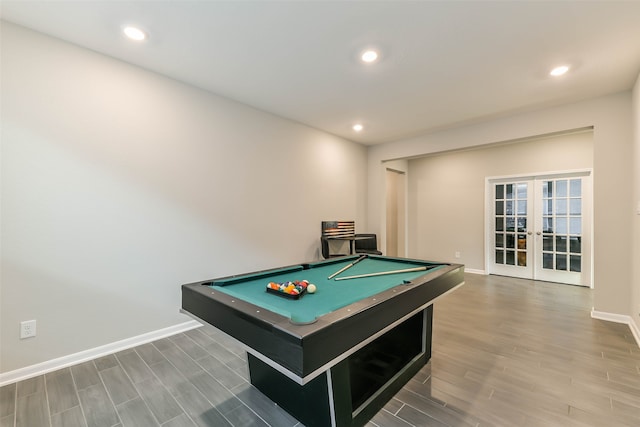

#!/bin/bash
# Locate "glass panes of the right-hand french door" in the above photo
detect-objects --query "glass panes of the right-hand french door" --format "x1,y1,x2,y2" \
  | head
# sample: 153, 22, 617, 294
541, 178, 582, 273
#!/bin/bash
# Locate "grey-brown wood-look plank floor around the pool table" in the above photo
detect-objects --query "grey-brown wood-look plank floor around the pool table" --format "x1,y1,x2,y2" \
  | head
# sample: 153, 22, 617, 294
0, 274, 640, 427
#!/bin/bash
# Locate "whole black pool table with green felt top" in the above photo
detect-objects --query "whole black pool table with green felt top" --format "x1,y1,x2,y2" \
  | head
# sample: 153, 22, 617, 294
182, 255, 464, 427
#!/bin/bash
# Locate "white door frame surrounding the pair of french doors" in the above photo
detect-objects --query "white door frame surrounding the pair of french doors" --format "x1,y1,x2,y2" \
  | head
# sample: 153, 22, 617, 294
484, 168, 595, 288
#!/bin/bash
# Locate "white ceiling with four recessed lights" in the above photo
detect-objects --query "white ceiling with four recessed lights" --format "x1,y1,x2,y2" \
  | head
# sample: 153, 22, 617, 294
0, 0, 640, 144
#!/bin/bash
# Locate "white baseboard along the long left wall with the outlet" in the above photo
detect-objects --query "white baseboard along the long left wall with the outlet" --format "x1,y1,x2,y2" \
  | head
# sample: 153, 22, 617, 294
0, 320, 202, 387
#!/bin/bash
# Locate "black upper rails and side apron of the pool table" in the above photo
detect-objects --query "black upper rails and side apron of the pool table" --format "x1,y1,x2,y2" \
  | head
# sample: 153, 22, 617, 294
182, 257, 464, 384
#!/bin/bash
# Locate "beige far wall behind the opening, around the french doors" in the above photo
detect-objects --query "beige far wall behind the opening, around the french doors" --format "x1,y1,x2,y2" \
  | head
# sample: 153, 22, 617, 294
408, 131, 593, 270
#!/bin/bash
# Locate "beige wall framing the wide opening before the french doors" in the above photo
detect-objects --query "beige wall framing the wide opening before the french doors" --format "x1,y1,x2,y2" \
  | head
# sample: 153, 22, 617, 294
367, 92, 637, 316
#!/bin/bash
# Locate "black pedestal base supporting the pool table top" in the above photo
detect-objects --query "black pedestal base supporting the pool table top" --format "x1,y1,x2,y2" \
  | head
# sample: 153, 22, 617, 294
247, 305, 433, 427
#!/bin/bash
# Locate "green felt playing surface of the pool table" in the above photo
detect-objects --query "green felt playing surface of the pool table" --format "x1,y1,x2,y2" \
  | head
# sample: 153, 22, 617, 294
211, 257, 437, 323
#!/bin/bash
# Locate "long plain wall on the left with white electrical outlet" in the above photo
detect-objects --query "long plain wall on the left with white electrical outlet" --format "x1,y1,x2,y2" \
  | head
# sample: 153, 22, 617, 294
0, 23, 367, 373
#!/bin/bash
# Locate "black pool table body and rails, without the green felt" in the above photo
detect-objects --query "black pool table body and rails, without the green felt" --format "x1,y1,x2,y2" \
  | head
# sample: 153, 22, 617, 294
182, 257, 464, 427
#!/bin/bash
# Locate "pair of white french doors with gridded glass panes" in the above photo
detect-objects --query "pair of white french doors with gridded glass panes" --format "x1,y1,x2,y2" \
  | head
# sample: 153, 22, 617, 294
488, 172, 591, 286
